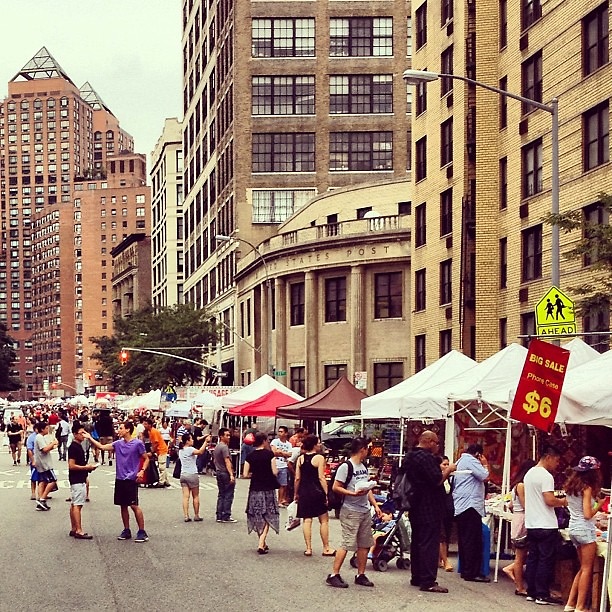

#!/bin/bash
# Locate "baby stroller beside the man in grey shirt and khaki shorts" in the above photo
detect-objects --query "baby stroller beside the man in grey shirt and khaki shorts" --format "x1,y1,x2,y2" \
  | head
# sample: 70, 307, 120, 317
350, 496, 410, 572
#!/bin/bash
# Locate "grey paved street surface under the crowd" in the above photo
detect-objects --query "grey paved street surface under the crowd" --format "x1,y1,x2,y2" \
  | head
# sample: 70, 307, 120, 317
0, 446, 533, 612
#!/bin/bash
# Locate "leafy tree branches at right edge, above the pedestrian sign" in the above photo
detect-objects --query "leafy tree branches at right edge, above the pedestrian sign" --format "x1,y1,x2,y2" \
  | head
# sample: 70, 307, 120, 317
545, 193, 612, 316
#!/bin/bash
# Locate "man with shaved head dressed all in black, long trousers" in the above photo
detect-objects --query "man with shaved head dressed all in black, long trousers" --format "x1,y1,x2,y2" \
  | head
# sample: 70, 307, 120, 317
401, 431, 457, 593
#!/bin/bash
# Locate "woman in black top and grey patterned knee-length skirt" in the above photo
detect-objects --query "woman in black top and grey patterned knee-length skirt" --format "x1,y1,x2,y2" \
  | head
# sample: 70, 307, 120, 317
242, 432, 279, 555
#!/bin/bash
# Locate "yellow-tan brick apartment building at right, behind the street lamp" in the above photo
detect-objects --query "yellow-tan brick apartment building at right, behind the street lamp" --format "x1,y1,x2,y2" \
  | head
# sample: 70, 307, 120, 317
411, 0, 612, 370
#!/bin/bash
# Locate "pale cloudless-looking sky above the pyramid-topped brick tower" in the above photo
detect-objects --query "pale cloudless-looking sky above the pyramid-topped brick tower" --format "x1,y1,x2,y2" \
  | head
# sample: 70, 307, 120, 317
0, 0, 182, 156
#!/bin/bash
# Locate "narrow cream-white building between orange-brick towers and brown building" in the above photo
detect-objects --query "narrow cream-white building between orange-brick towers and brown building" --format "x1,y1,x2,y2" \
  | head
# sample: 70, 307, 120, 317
151, 119, 184, 307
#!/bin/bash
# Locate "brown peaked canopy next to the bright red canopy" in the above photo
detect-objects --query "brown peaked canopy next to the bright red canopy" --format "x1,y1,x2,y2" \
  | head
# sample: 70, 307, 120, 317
276, 376, 368, 420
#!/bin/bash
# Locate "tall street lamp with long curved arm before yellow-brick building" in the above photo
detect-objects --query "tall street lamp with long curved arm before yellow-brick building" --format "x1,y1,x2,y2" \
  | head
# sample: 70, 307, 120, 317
402, 70, 560, 287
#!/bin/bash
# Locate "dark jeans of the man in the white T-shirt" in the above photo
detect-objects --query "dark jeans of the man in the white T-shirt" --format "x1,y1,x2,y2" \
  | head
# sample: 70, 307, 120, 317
525, 529, 559, 599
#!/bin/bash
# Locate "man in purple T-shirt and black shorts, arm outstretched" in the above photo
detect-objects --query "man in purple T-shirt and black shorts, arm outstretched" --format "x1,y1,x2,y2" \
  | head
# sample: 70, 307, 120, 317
83, 421, 149, 542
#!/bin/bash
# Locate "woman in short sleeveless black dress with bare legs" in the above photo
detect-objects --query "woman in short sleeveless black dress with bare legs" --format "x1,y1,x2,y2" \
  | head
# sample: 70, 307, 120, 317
294, 435, 336, 557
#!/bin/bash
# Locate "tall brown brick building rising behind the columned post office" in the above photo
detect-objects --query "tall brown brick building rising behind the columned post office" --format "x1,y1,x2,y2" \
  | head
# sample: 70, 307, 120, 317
182, 0, 411, 380
